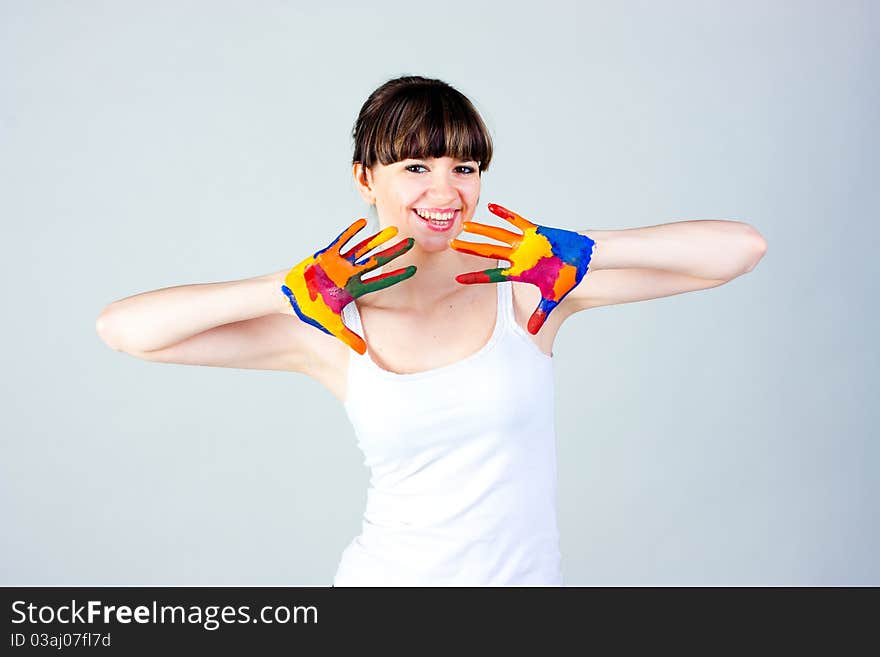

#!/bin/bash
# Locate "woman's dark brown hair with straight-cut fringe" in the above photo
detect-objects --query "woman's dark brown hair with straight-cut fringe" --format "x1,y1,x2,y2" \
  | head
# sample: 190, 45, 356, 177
352, 75, 492, 172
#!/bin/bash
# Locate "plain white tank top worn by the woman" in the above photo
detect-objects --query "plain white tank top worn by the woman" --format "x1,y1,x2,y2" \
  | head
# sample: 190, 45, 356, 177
333, 281, 562, 586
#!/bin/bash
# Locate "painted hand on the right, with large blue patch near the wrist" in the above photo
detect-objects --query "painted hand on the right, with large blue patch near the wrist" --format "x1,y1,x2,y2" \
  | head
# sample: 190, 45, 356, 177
449, 203, 595, 335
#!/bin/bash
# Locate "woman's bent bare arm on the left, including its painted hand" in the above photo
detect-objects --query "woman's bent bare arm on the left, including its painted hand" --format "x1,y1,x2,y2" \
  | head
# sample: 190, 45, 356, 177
96, 217, 416, 374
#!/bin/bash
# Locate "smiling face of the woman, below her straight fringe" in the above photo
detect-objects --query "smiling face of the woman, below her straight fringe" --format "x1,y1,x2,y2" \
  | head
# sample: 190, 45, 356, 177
354, 156, 480, 252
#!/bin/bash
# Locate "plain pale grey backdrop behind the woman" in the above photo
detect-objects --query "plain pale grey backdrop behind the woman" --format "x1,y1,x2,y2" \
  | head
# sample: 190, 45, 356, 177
0, 0, 880, 585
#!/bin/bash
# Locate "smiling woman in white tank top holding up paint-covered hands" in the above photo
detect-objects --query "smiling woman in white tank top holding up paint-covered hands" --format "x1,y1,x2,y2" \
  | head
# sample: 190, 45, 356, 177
97, 76, 766, 586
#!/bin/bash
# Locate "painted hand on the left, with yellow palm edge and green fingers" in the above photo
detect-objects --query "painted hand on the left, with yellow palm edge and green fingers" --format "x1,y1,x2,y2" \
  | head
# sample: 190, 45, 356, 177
281, 218, 416, 354
